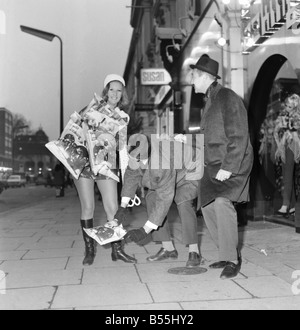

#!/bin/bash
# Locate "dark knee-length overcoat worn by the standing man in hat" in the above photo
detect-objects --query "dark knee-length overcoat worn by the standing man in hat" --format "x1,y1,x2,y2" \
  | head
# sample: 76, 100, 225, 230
199, 84, 253, 207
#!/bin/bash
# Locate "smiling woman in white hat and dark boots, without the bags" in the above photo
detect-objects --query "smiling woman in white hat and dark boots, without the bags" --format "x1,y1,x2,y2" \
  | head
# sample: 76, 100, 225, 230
74, 74, 136, 265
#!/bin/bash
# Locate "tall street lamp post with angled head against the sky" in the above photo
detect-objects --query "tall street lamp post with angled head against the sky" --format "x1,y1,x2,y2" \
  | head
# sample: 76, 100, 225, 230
20, 25, 64, 134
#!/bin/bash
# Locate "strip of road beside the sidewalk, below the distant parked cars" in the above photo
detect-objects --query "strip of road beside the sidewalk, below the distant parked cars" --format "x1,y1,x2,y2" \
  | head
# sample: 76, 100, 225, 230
0, 185, 63, 216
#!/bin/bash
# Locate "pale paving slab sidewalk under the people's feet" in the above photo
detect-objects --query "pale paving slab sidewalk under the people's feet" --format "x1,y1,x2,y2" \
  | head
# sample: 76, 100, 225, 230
0, 189, 300, 311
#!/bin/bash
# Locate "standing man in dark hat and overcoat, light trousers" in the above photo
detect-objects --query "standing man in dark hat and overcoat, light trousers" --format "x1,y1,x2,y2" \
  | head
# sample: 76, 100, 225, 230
190, 55, 253, 279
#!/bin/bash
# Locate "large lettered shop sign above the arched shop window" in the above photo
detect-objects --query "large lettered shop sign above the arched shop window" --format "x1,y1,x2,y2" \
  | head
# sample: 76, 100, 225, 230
244, 0, 300, 52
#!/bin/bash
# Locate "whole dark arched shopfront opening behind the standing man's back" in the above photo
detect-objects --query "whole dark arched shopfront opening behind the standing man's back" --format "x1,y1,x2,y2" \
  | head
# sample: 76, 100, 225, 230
249, 54, 300, 226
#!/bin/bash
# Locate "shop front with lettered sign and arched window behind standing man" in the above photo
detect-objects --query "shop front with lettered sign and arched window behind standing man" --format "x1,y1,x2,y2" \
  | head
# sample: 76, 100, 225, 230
244, 1, 300, 230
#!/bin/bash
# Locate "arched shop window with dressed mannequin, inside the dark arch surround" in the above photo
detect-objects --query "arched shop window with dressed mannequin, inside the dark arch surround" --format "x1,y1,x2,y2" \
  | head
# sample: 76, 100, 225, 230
258, 61, 300, 216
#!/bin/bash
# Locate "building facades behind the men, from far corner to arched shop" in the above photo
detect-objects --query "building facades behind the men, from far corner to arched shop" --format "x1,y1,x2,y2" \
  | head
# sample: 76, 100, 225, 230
124, 0, 300, 229
